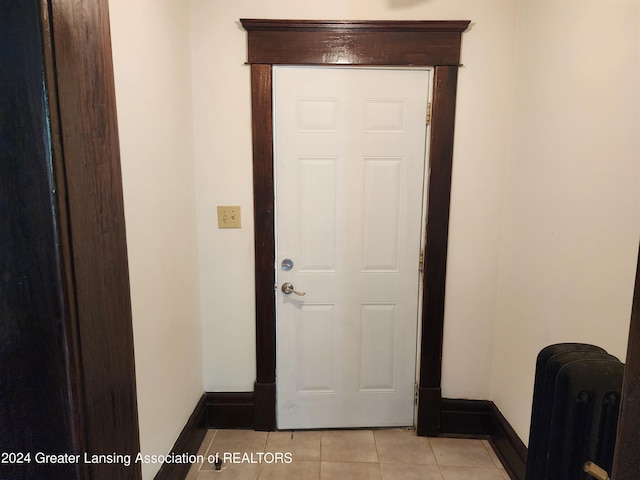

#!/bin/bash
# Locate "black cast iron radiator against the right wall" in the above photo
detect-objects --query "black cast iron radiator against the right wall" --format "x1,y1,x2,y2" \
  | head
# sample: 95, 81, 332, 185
526, 343, 624, 480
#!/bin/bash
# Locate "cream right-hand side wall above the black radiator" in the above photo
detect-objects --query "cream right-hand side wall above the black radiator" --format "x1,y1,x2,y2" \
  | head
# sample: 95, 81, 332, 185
492, 0, 640, 441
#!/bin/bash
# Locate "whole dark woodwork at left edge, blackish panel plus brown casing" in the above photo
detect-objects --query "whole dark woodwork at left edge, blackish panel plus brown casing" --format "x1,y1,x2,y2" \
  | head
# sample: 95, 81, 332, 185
0, 0, 141, 480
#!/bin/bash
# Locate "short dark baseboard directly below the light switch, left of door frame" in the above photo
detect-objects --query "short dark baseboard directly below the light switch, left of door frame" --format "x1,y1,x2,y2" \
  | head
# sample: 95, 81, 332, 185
205, 392, 255, 430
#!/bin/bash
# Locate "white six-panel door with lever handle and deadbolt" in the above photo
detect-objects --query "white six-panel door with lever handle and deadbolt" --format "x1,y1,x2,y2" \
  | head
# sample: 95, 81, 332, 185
273, 67, 430, 429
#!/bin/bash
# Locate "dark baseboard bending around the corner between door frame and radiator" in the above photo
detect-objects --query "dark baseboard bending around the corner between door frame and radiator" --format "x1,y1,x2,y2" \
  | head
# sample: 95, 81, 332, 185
440, 398, 527, 480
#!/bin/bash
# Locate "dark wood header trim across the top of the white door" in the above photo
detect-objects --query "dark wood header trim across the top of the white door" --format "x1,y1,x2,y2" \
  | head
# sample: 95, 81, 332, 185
240, 19, 469, 66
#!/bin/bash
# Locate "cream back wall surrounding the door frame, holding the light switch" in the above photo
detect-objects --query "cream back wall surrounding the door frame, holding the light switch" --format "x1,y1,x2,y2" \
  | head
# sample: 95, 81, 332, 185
190, 0, 515, 398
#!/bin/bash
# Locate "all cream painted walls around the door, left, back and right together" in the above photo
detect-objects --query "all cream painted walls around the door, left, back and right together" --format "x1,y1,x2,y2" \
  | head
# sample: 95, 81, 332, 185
110, 0, 640, 464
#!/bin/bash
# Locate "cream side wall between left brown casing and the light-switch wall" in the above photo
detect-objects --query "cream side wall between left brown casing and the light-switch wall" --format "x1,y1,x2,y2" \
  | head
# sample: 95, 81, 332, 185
109, 0, 203, 479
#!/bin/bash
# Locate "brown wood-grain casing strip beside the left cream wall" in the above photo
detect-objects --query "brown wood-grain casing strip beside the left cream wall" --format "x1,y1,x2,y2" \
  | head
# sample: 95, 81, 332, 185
46, 0, 141, 479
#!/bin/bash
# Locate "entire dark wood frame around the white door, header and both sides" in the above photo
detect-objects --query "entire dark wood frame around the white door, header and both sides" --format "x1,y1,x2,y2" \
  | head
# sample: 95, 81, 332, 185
240, 19, 470, 435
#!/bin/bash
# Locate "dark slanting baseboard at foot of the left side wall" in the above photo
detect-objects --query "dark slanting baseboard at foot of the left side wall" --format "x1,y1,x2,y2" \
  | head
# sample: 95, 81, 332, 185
154, 395, 208, 480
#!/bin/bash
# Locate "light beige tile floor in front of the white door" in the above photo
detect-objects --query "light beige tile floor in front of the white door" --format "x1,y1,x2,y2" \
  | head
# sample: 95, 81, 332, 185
185, 429, 509, 480
